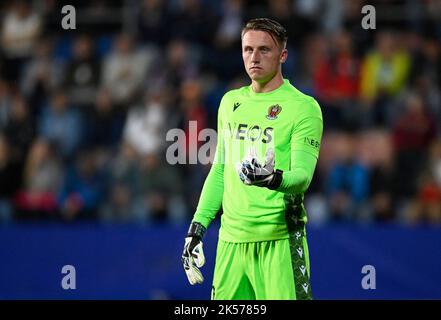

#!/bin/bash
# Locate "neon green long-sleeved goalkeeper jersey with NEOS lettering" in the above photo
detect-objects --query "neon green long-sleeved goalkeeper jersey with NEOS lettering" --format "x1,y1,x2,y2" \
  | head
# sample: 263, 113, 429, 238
193, 79, 323, 242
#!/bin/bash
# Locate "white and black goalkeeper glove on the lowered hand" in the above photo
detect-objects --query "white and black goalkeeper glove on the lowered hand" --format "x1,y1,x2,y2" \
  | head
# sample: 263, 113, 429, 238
182, 222, 206, 285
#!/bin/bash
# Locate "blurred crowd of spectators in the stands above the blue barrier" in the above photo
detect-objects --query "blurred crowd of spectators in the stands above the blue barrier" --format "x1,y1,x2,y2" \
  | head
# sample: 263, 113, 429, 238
0, 0, 441, 224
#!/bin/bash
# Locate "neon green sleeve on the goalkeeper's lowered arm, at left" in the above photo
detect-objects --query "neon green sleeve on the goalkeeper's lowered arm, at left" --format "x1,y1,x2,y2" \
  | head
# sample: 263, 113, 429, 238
192, 104, 225, 228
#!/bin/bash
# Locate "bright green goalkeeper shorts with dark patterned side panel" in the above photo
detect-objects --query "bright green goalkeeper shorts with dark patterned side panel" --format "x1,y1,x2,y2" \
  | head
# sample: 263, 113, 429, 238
211, 227, 312, 300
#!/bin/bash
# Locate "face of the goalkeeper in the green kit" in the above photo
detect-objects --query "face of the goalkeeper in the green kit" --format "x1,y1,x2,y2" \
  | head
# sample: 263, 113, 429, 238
242, 30, 287, 83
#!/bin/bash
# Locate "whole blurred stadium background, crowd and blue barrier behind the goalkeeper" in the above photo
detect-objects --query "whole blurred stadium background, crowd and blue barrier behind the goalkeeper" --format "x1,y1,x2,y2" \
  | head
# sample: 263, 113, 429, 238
0, 0, 441, 299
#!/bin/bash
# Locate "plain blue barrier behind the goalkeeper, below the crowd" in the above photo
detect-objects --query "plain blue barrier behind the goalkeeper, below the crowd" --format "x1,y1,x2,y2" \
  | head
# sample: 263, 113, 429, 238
0, 224, 441, 299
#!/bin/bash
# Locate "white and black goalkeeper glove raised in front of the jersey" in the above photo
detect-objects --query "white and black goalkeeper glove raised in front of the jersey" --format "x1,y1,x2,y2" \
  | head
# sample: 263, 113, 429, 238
237, 147, 283, 190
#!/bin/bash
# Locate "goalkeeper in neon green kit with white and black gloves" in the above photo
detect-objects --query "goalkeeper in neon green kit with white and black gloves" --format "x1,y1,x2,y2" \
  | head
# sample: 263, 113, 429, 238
182, 18, 323, 300
